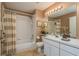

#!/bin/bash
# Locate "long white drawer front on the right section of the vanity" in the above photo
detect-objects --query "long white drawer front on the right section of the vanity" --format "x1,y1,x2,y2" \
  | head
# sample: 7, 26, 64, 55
60, 44, 79, 56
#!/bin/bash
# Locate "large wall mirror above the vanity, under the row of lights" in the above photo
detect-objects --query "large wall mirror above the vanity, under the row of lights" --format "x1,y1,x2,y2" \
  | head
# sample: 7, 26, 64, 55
48, 3, 76, 38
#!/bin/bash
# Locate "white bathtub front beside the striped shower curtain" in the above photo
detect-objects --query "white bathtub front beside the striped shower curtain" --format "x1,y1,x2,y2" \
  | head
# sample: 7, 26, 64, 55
16, 42, 35, 52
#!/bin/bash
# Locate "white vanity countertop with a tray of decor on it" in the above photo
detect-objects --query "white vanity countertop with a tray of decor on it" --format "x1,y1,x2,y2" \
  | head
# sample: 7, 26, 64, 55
44, 35, 79, 49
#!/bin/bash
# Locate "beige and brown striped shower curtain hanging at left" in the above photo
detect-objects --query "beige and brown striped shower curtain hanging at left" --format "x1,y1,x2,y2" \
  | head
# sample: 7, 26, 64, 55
1, 9, 16, 56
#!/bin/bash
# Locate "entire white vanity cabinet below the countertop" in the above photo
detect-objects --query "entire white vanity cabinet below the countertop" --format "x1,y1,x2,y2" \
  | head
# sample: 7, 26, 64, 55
44, 38, 79, 56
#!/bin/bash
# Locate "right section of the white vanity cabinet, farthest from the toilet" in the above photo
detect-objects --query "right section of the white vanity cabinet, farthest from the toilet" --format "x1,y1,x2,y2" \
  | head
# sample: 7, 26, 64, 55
60, 43, 79, 56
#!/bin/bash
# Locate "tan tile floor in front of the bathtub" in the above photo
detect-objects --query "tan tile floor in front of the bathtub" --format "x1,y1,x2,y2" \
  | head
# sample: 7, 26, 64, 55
16, 49, 44, 56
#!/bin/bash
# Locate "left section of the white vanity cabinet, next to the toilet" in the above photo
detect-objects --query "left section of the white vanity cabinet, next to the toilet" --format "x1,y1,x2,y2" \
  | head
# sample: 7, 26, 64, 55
44, 39, 59, 56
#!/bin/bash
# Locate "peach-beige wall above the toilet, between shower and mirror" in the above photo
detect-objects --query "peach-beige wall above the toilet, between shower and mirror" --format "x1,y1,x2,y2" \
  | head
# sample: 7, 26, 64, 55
35, 10, 47, 41
